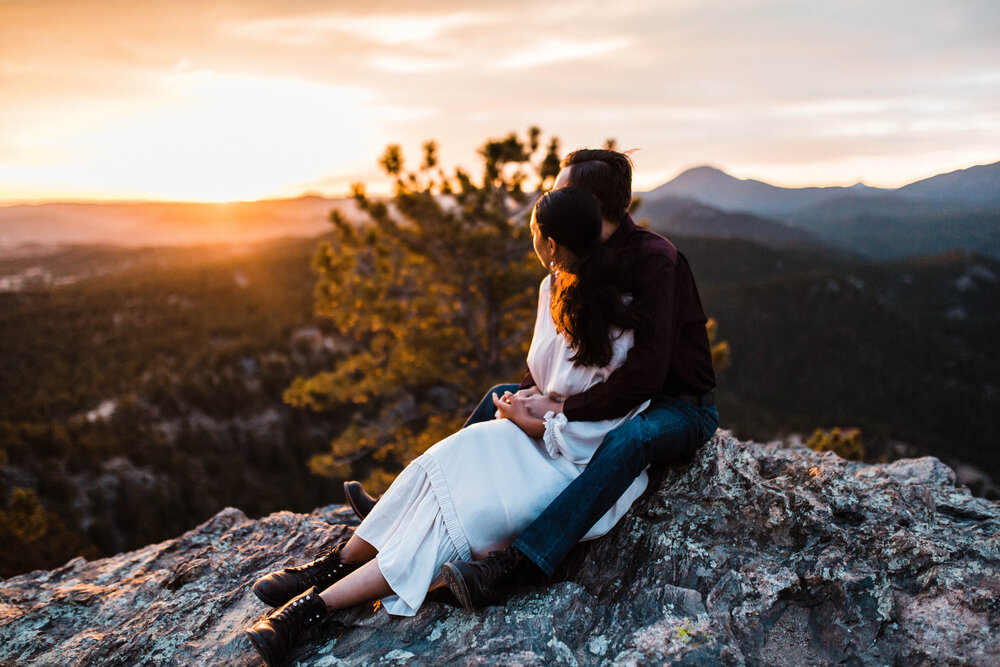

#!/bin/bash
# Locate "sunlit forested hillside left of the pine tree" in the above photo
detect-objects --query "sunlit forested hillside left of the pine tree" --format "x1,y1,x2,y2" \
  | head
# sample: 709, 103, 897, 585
0, 240, 354, 574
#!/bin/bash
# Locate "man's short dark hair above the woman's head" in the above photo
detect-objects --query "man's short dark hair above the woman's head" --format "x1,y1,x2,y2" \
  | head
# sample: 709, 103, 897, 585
560, 148, 632, 222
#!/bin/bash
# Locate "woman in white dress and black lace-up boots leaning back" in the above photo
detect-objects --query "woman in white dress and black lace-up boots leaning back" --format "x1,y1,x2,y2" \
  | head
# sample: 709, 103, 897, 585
247, 187, 648, 663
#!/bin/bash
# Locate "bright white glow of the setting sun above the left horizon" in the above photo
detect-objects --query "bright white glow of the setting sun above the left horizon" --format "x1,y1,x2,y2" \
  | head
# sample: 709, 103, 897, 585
0, 71, 380, 202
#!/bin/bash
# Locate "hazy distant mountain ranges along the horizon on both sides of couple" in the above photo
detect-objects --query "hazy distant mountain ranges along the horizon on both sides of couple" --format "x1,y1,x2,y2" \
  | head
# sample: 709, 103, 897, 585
0, 162, 1000, 260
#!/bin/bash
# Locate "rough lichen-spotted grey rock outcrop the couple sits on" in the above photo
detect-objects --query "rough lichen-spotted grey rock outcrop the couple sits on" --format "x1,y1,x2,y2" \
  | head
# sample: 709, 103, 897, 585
0, 432, 1000, 666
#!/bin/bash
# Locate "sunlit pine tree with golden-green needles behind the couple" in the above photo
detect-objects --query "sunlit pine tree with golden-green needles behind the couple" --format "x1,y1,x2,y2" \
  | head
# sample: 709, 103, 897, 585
285, 128, 559, 490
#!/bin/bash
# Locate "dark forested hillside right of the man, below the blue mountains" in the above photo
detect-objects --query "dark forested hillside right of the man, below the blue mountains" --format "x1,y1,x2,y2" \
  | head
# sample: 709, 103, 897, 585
690, 240, 1000, 475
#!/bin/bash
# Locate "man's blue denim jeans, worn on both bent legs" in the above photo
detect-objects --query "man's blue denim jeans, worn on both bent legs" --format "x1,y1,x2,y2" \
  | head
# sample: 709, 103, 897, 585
466, 385, 719, 576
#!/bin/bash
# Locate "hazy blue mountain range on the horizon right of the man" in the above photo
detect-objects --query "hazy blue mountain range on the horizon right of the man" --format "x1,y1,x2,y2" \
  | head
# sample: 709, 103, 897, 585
640, 162, 1000, 260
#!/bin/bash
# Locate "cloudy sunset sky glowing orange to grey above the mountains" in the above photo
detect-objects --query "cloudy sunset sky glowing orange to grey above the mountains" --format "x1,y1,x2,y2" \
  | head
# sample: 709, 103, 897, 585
0, 0, 1000, 204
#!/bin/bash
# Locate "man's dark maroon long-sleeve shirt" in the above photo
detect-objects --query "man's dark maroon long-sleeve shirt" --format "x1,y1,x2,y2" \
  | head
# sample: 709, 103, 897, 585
521, 216, 715, 421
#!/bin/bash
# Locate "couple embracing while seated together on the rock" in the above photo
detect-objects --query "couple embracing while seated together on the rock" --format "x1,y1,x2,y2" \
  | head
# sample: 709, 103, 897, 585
247, 150, 718, 663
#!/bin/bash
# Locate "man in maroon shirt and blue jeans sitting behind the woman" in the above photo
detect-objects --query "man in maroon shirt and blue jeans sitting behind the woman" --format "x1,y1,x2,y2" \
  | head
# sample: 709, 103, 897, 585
345, 149, 718, 611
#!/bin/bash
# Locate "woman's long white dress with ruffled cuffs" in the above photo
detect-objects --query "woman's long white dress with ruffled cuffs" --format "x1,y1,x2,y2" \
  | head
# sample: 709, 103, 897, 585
357, 277, 649, 616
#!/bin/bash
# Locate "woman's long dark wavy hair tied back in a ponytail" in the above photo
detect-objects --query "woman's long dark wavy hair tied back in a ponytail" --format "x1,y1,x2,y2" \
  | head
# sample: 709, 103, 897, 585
535, 186, 637, 366
